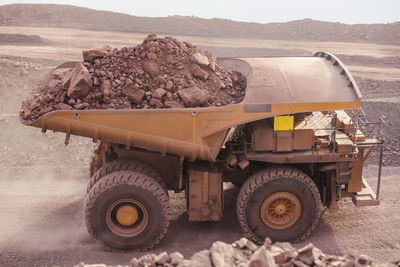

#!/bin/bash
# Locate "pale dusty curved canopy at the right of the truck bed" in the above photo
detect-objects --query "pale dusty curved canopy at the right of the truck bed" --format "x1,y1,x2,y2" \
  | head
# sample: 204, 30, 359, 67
219, 53, 361, 108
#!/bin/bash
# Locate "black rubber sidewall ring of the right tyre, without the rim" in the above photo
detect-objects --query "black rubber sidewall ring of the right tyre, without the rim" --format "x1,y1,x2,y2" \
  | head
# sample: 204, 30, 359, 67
245, 177, 318, 242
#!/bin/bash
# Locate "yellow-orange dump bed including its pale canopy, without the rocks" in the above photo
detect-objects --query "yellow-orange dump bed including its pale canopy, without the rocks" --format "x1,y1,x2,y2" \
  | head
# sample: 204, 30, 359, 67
23, 52, 361, 161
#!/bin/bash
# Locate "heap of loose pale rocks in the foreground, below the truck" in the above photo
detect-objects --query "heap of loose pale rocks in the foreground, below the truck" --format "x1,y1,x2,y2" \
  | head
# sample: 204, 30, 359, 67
75, 237, 400, 267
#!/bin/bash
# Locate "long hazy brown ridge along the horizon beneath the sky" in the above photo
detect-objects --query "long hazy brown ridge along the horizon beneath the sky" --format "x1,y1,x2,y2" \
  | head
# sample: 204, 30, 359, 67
0, 4, 400, 44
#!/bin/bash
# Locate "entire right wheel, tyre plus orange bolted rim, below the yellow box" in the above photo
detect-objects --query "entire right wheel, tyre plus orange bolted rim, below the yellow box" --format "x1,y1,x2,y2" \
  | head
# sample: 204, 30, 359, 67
237, 167, 322, 243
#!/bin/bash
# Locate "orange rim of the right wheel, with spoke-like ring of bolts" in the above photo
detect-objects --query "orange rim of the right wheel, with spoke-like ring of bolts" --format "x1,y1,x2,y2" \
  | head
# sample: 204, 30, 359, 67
260, 192, 301, 229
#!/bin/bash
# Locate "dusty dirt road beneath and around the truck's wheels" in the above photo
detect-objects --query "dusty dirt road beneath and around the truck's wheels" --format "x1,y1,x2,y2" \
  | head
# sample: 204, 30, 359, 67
0, 166, 400, 266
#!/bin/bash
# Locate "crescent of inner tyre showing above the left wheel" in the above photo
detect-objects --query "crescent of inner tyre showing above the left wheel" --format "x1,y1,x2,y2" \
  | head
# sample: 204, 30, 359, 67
86, 159, 168, 195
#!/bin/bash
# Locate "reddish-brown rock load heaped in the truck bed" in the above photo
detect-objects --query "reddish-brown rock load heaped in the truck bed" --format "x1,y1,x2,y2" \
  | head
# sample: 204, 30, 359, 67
20, 34, 246, 121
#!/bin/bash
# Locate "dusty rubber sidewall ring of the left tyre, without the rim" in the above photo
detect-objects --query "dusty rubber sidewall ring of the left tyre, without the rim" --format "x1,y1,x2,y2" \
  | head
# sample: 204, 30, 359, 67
89, 184, 167, 250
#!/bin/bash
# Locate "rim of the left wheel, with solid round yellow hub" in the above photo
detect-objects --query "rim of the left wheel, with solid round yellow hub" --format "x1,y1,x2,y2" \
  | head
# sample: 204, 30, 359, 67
106, 198, 149, 237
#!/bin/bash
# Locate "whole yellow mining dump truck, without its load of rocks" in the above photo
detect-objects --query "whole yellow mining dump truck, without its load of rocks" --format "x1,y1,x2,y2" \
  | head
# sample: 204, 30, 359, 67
21, 52, 384, 250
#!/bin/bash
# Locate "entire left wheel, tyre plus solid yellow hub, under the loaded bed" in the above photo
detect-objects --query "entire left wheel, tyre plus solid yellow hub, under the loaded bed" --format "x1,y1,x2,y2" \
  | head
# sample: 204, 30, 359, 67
84, 171, 169, 250
